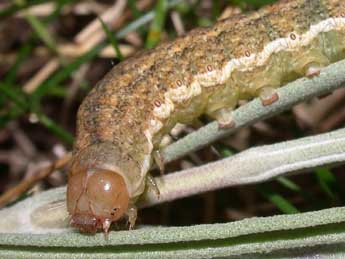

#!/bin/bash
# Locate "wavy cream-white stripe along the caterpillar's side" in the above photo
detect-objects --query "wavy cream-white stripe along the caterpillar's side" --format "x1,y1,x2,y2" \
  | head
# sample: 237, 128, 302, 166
148, 17, 345, 148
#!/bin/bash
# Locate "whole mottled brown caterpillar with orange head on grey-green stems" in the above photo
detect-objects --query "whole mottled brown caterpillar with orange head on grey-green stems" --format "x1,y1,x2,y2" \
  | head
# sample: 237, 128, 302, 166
67, 0, 345, 233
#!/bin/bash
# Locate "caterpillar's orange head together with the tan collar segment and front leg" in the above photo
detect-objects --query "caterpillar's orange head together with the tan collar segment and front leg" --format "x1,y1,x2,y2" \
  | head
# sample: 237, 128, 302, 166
67, 142, 145, 233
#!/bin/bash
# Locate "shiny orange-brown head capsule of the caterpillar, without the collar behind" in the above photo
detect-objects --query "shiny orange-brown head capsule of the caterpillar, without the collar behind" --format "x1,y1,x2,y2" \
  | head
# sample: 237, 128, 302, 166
67, 169, 129, 233
